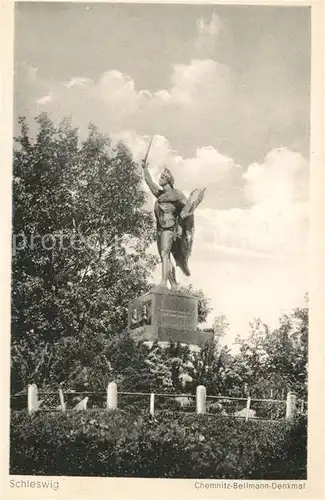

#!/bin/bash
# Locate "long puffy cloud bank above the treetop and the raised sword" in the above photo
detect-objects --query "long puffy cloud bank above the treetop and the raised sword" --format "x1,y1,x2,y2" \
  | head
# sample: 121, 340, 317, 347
16, 55, 232, 156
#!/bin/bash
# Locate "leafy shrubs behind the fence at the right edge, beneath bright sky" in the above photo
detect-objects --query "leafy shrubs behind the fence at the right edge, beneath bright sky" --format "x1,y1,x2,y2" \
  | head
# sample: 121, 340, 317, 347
233, 304, 308, 398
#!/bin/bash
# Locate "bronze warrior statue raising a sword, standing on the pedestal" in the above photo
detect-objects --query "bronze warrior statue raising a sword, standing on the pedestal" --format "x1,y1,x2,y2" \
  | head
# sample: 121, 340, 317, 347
142, 139, 205, 289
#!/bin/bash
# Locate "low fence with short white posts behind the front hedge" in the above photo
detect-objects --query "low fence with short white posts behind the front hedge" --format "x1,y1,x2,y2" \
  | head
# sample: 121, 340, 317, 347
11, 382, 307, 421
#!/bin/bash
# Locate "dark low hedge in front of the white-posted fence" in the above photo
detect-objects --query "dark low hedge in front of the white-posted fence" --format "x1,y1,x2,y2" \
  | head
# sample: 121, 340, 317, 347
10, 410, 306, 479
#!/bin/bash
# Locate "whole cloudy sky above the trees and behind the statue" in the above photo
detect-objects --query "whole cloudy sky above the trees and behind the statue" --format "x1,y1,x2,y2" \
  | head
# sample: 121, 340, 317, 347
14, 2, 310, 344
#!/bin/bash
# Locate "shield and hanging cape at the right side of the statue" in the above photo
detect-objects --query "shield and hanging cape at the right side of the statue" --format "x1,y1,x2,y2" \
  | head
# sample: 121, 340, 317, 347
171, 188, 206, 276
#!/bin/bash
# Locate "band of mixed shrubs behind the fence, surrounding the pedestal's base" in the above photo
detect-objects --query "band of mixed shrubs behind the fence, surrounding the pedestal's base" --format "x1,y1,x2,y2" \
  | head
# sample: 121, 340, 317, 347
13, 300, 307, 398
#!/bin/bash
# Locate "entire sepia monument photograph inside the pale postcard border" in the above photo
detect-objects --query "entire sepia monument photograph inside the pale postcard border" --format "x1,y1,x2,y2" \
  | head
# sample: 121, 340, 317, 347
9, 2, 311, 482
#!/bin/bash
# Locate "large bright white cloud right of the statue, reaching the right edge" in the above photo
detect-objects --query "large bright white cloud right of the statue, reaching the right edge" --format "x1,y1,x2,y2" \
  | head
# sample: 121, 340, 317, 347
192, 148, 309, 258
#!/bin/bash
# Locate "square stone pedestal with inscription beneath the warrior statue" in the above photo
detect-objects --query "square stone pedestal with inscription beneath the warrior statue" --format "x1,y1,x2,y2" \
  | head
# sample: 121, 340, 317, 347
128, 286, 209, 345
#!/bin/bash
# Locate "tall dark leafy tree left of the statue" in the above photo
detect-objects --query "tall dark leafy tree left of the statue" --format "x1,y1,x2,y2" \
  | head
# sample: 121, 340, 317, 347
12, 114, 157, 392
